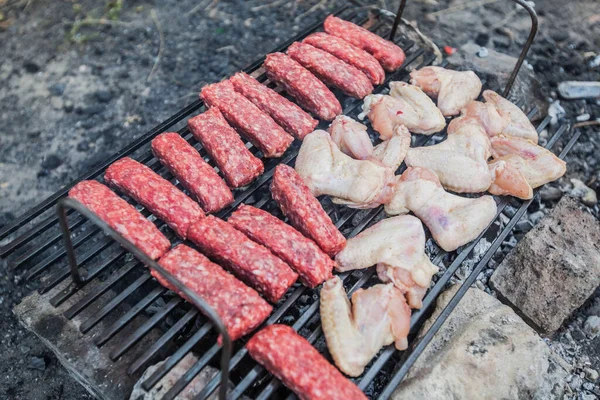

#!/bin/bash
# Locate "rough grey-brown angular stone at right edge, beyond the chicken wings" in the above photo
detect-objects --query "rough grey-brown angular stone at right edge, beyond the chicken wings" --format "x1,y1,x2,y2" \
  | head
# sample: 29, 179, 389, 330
490, 196, 600, 334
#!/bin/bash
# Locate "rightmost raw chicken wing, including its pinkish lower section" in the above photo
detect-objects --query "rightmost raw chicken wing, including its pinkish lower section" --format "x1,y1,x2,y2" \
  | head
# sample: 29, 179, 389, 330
490, 135, 567, 199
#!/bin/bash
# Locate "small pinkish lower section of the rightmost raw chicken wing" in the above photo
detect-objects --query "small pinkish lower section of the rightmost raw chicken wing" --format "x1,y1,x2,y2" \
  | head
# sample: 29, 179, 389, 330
488, 154, 533, 200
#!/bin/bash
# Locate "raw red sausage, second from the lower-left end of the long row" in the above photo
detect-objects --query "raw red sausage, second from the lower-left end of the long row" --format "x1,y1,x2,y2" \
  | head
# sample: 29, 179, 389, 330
104, 157, 204, 239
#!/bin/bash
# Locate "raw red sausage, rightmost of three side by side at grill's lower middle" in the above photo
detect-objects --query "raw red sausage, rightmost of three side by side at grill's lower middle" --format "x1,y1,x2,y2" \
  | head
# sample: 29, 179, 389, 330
228, 204, 334, 288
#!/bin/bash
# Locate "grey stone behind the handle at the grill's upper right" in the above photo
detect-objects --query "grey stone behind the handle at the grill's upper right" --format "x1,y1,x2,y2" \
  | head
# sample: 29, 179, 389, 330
448, 42, 548, 115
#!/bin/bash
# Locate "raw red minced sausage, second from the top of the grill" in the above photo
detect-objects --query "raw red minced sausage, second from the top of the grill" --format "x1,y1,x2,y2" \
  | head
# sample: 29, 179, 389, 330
302, 32, 385, 85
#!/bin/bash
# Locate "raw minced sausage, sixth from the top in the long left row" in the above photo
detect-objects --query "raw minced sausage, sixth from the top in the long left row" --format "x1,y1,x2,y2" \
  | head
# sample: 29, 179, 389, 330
200, 81, 294, 157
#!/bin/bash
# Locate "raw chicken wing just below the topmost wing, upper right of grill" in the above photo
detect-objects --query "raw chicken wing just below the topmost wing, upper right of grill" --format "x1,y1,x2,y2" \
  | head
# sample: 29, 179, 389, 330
448, 90, 538, 143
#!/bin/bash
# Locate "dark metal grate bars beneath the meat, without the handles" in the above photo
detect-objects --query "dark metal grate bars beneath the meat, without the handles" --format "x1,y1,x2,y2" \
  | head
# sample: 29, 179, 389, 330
0, 5, 578, 399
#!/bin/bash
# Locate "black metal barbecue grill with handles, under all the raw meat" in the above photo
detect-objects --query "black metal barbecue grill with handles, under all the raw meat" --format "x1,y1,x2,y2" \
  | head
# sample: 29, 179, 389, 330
0, 0, 579, 399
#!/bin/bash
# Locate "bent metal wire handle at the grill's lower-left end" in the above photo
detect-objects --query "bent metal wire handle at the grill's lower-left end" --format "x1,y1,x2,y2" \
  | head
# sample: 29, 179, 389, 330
56, 197, 232, 400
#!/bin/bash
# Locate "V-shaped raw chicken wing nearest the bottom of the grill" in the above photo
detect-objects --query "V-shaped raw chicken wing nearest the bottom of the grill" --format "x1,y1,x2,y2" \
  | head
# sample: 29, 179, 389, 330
321, 276, 410, 376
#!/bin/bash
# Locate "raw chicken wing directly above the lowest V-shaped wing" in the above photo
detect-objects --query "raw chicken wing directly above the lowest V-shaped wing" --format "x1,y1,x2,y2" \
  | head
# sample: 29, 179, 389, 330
335, 215, 438, 308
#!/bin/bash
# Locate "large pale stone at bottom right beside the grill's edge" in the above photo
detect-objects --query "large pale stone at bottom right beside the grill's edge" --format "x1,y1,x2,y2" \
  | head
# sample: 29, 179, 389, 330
392, 285, 570, 400
